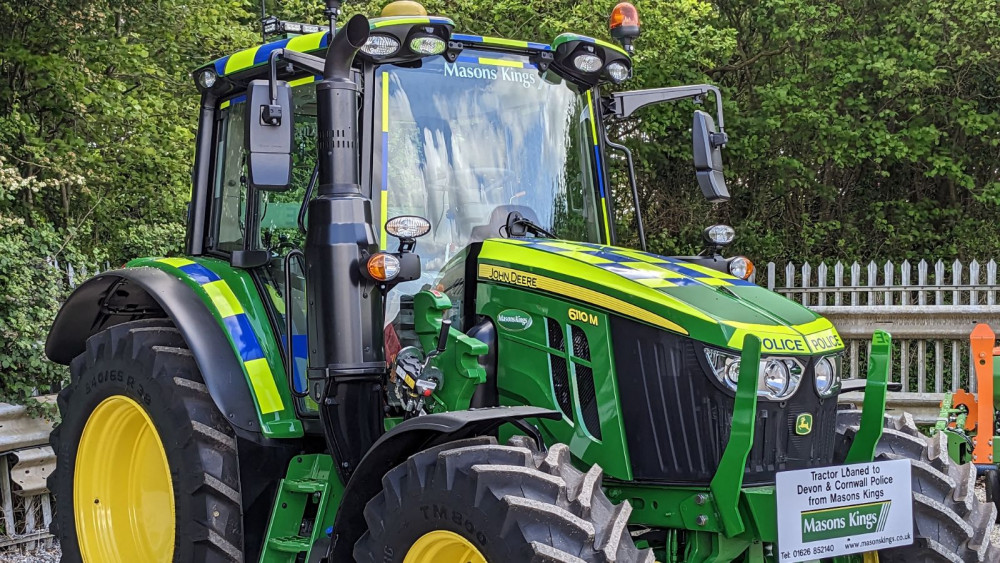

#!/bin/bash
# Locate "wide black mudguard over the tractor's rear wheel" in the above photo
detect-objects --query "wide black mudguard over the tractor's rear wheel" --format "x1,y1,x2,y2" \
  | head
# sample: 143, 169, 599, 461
45, 268, 261, 441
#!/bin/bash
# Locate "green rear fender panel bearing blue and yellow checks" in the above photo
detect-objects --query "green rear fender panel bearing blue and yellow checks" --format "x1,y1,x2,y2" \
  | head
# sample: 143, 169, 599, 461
126, 257, 303, 438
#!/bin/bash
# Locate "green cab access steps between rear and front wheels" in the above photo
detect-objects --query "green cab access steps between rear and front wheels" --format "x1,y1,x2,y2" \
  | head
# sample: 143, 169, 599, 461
260, 454, 344, 563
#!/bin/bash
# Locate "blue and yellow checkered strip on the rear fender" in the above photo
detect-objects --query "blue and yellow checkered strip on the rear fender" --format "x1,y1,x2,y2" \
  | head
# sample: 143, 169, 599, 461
157, 258, 285, 414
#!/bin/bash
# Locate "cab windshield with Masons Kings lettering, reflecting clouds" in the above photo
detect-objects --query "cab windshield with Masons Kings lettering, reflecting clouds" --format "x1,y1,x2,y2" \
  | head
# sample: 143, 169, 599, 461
376, 49, 603, 276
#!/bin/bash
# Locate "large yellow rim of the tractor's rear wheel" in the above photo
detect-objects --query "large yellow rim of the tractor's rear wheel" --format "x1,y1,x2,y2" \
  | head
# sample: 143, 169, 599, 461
73, 395, 175, 563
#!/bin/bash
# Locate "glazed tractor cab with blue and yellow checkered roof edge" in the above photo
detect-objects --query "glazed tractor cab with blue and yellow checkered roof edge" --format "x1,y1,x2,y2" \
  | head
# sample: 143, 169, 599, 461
188, 2, 728, 406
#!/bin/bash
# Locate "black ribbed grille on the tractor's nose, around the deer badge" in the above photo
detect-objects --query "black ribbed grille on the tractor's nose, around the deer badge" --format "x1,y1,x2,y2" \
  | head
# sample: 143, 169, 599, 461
611, 317, 837, 485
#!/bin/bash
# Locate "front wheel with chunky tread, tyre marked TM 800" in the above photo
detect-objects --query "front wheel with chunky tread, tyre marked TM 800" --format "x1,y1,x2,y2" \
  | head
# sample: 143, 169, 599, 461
354, 437, 653, 563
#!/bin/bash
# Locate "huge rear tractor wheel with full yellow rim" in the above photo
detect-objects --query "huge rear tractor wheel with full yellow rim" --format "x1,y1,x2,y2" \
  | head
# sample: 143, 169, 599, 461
49, 319, 243, 563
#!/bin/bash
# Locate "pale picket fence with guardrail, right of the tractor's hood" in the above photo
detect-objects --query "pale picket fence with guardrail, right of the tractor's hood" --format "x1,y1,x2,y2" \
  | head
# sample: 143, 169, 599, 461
760, 260, 1000, 393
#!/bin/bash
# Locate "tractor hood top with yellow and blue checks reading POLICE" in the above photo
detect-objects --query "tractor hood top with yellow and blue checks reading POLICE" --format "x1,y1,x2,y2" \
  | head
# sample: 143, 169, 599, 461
478, 239, 844, 355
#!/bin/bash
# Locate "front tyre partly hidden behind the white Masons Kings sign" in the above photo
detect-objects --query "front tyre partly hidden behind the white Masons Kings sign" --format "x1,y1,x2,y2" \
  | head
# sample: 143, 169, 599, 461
836, 410, 1000, 563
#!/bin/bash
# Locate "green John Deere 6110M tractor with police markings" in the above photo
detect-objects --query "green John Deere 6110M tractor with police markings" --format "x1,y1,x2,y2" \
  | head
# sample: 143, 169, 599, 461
46, 0, 1000, 563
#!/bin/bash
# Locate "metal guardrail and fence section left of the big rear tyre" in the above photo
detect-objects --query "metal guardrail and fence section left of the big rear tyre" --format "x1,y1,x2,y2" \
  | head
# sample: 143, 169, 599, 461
0, 395, 56, 549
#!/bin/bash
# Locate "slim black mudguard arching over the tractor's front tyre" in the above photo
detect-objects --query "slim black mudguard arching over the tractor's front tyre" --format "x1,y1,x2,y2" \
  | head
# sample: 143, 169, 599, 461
328, 407, 562, 562
